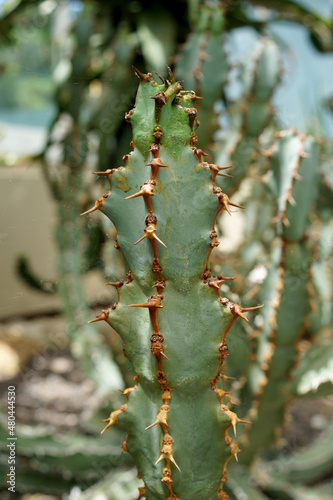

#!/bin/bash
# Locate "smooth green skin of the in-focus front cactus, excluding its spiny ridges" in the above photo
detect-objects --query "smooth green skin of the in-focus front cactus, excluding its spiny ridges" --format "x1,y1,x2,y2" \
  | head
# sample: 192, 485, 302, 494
98, 81, 231, 500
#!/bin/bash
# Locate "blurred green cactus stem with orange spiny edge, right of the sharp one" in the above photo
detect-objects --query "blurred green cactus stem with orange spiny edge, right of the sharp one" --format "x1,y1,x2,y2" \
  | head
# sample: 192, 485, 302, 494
241, 130, 319, 464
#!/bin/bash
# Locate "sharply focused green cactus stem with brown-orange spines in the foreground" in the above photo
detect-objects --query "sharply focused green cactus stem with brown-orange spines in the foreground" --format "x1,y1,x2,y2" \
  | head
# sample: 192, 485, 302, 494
83, 70, 260, 500
